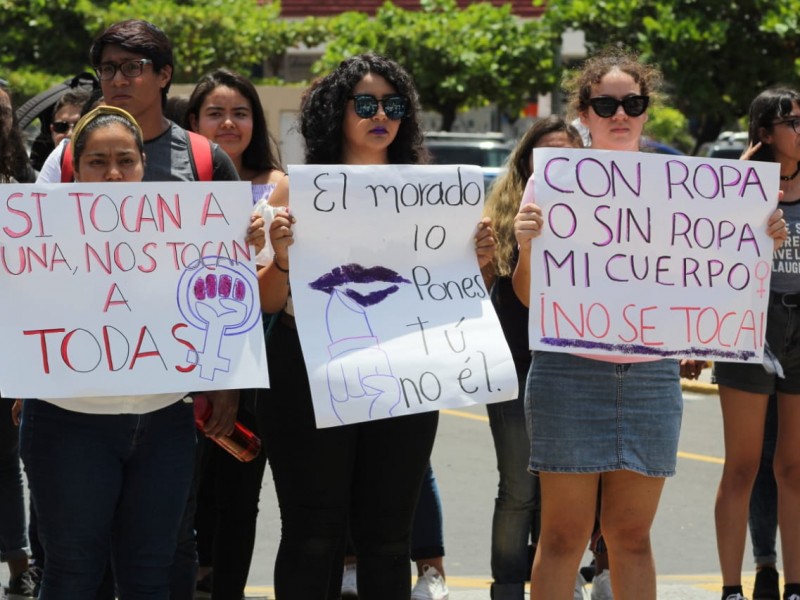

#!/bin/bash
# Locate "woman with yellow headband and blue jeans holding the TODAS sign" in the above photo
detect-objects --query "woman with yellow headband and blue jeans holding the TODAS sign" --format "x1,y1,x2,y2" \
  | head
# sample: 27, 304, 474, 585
14, 106, 264, 600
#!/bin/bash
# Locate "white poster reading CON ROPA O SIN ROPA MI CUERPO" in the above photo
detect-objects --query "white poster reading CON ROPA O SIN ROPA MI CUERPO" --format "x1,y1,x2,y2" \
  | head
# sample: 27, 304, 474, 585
529, 148, 779, 362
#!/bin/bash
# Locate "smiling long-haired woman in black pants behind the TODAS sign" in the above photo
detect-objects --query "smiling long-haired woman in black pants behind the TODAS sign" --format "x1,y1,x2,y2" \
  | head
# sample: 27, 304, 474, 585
185, 69, 291, 598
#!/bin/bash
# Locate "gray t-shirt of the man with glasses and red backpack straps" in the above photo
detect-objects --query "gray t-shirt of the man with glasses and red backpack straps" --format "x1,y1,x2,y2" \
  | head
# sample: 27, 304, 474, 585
36, 123, 239, 183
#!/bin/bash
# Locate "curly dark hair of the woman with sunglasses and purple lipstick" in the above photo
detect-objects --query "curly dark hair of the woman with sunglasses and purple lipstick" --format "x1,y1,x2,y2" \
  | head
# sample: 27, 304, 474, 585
300, 54, 428, 164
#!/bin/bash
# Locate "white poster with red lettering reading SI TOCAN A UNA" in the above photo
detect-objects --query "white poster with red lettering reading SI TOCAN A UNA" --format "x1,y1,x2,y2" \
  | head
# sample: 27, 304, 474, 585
0, 182, 268, 398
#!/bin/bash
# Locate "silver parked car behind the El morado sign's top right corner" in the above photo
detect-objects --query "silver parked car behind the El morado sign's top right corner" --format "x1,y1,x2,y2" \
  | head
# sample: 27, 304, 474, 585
425, 131, 514, 191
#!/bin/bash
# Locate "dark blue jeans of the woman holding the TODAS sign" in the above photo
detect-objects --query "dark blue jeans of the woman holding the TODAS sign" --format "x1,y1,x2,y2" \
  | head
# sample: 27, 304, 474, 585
20, 400, 196, 600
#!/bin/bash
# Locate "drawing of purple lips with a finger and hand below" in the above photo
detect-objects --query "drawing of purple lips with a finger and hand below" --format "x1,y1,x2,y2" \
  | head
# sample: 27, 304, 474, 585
309, 264, 411, 424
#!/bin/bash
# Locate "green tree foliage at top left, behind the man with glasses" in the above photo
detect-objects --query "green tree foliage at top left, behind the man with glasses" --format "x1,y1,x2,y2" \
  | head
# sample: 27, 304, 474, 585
0, 0, 328, 100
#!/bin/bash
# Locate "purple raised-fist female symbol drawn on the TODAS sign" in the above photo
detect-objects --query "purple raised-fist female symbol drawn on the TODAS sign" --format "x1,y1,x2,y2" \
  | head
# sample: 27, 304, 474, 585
177, 256, 260, 381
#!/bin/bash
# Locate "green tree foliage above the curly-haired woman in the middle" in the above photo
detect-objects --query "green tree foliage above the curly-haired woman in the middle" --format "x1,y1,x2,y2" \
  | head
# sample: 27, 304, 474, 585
315, 0, 556, 130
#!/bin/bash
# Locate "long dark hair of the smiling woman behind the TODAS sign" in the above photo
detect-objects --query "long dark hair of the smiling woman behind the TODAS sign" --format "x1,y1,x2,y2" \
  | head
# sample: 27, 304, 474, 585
183, 68, 282, 173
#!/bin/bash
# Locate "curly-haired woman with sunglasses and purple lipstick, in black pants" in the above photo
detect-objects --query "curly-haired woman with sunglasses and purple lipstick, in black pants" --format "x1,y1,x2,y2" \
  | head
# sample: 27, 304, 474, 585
258, 54, 493, 600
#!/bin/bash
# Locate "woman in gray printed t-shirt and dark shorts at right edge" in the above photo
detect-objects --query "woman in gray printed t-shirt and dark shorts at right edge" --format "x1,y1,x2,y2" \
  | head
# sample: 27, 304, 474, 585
714, 88, 800, 599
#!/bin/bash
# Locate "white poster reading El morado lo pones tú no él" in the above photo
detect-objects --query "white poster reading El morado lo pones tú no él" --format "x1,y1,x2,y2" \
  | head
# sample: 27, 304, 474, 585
289, 165, 517, 427
